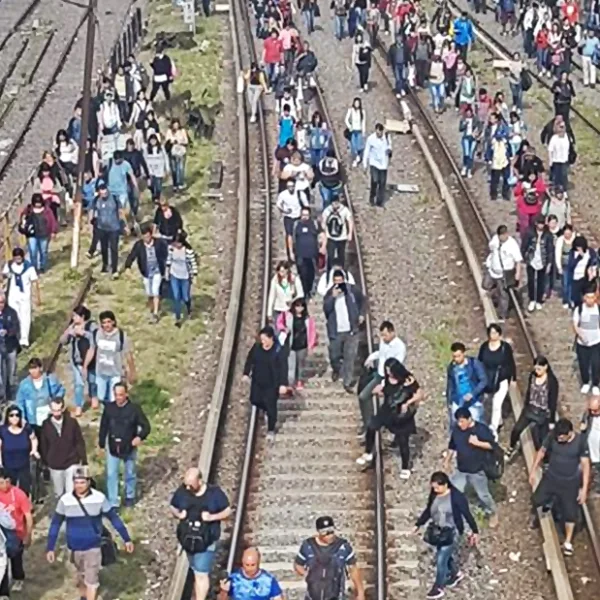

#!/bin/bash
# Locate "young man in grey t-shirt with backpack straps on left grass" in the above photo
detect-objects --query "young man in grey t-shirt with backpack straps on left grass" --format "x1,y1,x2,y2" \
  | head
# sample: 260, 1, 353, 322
82, 310, 135, 402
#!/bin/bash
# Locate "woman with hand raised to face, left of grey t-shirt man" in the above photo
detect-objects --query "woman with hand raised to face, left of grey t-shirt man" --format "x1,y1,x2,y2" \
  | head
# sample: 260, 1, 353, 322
60, 305, 98, 417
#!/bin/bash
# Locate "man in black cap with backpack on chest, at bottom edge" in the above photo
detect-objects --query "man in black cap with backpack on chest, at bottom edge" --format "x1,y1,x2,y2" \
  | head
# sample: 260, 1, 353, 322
294, 517, 365, 600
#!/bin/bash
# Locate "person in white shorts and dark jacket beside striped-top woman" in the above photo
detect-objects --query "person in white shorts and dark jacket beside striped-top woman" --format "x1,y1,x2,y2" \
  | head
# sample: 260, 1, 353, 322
123, 225, 169, 323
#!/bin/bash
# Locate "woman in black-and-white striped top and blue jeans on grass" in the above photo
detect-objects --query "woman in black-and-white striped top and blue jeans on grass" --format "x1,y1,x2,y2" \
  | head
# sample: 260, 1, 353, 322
165, 231, 198, 327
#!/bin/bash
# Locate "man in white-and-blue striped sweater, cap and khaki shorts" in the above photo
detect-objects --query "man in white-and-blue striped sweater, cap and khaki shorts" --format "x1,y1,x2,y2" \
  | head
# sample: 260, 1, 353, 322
46, 467, 133, 600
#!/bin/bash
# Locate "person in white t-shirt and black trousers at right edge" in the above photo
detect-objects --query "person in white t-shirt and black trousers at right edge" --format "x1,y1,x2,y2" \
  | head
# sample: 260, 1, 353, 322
573, 284, 600, 396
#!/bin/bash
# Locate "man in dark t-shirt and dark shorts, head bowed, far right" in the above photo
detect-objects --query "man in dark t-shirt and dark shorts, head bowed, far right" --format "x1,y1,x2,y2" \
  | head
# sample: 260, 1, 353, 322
529, 419, 590, 556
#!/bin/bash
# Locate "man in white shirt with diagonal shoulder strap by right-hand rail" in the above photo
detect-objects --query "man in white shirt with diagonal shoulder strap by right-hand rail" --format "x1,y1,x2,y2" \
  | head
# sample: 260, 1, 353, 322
482, 225, 523, 320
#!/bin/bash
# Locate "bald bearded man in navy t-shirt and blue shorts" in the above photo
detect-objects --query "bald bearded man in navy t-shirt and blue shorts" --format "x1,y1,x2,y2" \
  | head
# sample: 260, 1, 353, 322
171, 468, 231, 600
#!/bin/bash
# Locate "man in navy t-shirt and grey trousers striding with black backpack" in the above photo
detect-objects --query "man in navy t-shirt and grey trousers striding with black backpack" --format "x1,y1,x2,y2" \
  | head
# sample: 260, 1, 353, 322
444, 407, 498, 528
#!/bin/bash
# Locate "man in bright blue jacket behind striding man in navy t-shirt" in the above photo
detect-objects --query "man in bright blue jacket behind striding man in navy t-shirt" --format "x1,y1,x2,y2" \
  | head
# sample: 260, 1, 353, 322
446, 342, 487, 428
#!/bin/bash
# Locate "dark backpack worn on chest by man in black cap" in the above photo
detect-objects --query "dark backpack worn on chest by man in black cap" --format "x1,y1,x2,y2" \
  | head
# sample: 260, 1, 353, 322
306, 539, 346, 600
